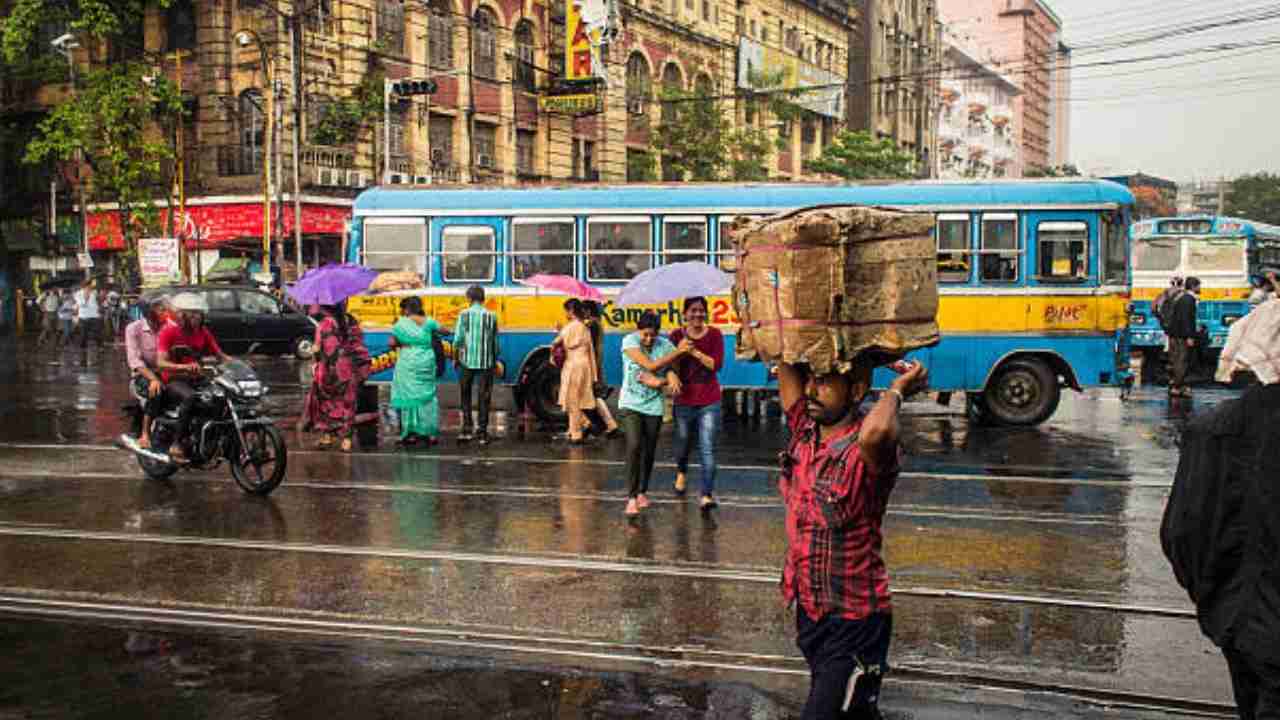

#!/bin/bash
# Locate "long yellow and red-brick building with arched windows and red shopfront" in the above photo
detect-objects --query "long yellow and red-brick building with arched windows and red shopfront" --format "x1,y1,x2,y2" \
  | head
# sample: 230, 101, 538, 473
7, 0, 854, 281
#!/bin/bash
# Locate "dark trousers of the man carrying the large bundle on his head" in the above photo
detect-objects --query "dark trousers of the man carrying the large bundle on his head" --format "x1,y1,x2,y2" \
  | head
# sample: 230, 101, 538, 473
796, 603, 893, 720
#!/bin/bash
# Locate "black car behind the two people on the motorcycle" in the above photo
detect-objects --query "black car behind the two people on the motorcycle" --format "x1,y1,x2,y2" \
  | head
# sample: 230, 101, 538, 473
141, 284, 316, 359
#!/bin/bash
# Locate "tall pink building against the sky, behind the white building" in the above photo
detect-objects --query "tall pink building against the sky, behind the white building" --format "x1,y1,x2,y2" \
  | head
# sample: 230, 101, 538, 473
938, 0, 1071, 168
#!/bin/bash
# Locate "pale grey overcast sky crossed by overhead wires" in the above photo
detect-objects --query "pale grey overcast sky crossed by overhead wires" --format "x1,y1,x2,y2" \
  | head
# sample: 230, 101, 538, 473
1050, 0, 1280, 181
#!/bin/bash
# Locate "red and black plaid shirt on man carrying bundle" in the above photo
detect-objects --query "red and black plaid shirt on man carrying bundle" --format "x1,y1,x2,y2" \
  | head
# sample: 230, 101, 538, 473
778, 400, 899, 620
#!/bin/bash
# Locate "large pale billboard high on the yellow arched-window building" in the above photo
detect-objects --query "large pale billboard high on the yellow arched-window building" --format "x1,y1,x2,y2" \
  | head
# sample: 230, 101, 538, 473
737, 37, 845, 119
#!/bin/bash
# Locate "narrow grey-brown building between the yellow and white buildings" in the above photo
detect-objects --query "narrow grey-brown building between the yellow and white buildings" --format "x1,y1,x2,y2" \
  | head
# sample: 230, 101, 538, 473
847, 0, 942, 176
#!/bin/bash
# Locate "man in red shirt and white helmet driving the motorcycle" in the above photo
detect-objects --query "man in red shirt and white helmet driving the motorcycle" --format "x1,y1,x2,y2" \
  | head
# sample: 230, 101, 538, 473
156, 292, 232, 462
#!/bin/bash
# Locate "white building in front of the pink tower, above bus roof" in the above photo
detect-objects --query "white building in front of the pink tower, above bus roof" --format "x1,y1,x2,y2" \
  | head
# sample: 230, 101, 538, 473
937, 32, 1021, 178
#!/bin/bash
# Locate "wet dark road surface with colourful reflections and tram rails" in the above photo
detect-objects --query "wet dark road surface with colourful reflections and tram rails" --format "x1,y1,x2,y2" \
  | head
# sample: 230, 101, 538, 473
0, 345, 1230, 717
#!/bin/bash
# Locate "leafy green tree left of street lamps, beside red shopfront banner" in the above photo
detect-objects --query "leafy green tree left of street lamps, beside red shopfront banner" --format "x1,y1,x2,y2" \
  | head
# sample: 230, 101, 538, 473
23, 63, 183, 278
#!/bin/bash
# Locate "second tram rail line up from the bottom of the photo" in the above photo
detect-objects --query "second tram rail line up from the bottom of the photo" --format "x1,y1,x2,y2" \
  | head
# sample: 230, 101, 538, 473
0, 523, 1196, 619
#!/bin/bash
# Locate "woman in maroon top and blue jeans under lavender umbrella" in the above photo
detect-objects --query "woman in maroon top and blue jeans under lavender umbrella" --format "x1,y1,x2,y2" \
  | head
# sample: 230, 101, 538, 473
671, 297, 724, 510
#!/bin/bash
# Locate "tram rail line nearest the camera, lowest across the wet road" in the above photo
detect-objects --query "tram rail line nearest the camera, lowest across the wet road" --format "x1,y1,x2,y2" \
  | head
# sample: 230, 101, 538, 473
0, 596, 1234, 719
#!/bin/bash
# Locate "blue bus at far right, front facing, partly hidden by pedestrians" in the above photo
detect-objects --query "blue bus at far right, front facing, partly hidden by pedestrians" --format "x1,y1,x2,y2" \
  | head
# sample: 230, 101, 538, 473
1129, 215, 1280, 377
